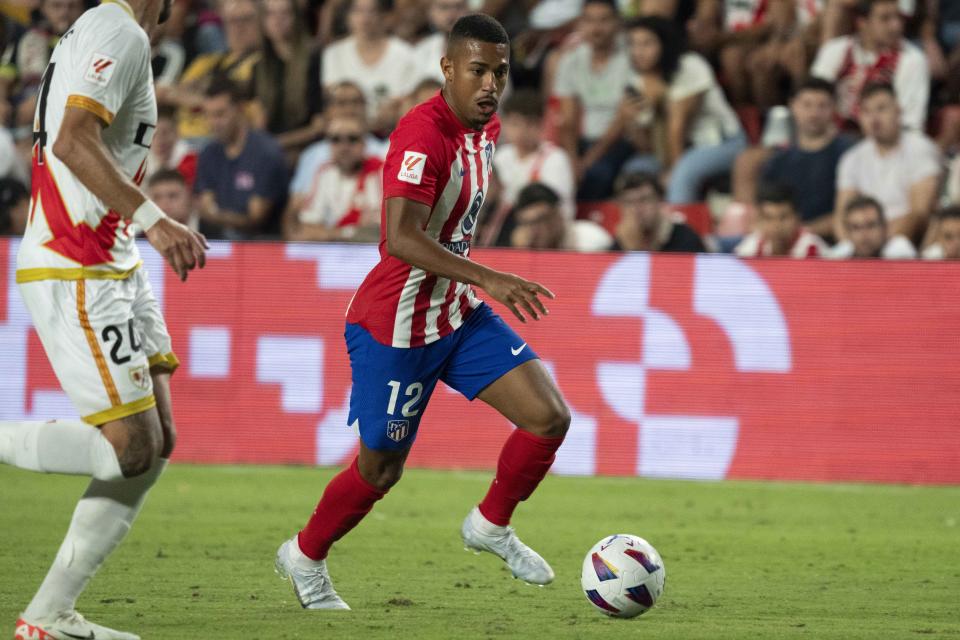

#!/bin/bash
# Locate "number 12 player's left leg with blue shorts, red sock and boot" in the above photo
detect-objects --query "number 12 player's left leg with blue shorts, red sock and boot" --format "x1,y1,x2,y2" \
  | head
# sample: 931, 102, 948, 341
276, 325, 444, 609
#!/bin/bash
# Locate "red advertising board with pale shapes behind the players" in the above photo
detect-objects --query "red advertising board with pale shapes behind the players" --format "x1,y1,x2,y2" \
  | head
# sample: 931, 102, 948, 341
0, 240, 960, 483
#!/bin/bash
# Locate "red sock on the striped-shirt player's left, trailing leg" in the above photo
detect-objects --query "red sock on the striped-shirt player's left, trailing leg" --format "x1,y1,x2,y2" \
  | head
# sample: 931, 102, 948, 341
298, 458, 387, 560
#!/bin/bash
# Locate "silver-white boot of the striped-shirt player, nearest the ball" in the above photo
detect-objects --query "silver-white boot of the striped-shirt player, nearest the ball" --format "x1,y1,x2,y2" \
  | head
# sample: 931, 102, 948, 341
460, 507, 554, 586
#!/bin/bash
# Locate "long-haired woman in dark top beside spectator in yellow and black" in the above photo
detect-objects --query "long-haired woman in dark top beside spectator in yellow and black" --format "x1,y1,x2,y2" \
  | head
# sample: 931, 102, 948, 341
253, 0, 322, 151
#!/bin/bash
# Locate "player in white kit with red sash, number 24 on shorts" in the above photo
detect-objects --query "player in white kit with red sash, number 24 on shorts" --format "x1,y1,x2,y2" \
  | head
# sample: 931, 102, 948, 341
0, 0, 205, 640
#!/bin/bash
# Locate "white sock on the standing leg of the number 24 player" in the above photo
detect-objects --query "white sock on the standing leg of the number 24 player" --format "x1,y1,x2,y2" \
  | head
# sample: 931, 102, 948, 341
24, 458, 167, 619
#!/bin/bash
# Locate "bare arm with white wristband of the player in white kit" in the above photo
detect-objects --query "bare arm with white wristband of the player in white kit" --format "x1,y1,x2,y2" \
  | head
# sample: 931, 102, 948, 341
52, 107, 206, 280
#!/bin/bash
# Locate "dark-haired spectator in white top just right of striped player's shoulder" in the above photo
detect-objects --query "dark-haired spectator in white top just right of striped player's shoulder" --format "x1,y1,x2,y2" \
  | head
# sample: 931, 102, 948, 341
493, 89, 575, 220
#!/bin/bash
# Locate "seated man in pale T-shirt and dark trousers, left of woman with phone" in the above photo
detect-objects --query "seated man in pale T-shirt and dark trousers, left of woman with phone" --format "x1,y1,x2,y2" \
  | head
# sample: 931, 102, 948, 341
553, 0, 633, 200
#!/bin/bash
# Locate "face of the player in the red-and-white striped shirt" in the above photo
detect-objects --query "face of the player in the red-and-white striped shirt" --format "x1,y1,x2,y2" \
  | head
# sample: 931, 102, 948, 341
441, 40, 510, 130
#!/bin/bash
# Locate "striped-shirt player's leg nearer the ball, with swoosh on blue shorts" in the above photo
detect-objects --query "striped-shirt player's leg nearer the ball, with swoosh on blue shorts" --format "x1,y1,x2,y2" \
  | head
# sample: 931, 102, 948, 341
443, 305, 570, 584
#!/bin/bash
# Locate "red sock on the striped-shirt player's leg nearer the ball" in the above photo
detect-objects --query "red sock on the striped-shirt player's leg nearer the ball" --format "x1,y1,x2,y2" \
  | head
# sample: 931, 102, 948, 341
480, 429, 563, 527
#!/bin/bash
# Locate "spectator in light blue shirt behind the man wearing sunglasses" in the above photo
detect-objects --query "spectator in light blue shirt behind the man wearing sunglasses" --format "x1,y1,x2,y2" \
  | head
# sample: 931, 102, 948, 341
290, 80, 387, 202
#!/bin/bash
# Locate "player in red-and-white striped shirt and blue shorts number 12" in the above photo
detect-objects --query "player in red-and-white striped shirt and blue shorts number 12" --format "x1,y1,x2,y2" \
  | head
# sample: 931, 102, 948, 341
276, 14, 570, 609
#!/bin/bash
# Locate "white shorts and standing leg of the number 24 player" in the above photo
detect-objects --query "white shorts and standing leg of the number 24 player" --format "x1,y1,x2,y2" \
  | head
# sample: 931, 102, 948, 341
12, 273, 176, 640
